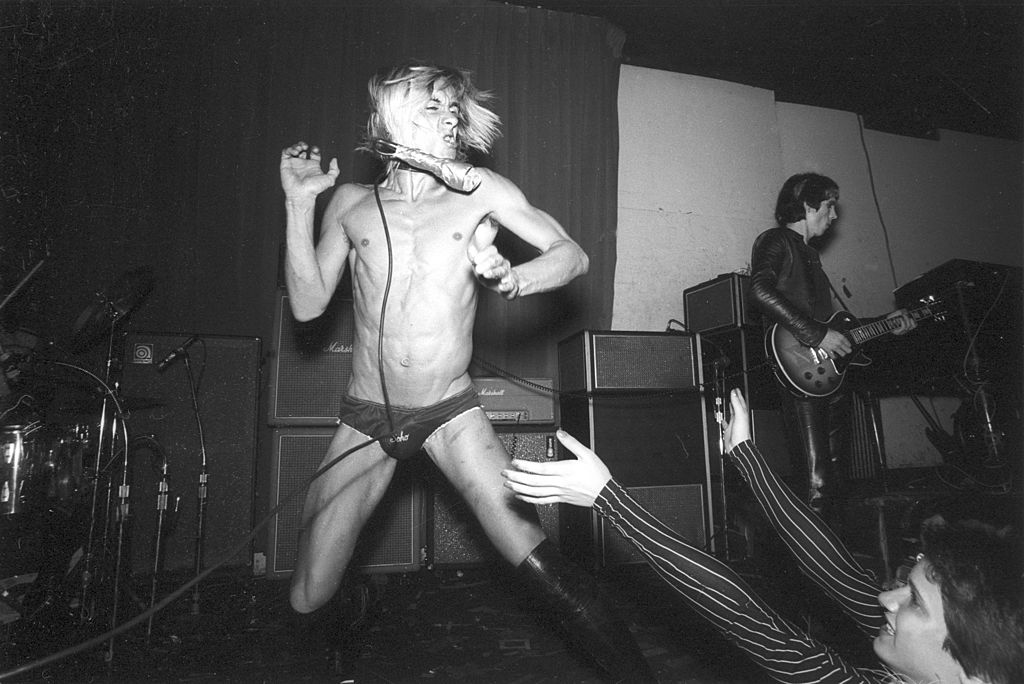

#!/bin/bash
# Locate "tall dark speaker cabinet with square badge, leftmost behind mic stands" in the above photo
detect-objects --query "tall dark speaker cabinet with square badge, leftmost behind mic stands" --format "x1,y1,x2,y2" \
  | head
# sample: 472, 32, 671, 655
121, 332, 261, 574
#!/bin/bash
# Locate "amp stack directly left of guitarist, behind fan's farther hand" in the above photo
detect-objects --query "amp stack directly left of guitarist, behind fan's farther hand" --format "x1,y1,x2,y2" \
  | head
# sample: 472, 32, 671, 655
683, 273, 793, 560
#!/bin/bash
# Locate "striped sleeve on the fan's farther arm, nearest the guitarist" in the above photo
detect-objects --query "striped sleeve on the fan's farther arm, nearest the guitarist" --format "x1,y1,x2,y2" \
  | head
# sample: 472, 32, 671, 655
729, 440, 885, 636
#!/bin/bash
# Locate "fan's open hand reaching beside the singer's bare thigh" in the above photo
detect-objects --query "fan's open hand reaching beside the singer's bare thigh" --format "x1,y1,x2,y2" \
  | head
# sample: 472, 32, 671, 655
502, 430, 611, 508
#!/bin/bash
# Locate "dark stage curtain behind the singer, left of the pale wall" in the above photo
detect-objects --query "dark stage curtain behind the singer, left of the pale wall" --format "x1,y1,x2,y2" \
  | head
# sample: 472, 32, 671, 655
0, 0, 624, 377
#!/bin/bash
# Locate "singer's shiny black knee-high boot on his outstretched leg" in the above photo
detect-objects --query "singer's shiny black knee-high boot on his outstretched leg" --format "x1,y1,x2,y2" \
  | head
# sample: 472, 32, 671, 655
517, 540, 656, 682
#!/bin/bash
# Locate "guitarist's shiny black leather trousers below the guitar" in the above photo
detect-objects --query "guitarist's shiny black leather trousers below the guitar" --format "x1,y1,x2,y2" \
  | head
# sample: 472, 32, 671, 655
779, 386, 850, 530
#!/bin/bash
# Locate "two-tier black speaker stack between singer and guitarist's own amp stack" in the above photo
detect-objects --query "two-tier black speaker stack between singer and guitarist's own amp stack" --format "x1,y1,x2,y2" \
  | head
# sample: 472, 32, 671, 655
558, 331, 714, 564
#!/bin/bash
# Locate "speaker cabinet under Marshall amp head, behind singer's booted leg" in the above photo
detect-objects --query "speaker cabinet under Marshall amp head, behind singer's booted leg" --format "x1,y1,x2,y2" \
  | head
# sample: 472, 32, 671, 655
429, 431, 559, 568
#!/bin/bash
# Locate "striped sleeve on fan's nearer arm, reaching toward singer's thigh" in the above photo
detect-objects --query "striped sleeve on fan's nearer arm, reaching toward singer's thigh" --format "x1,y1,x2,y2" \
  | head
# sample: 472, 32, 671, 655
594, 479, 886, 684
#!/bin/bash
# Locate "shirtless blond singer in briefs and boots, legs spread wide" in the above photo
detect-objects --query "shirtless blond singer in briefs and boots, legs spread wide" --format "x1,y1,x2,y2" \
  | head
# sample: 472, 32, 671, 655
281, 65, 650, 681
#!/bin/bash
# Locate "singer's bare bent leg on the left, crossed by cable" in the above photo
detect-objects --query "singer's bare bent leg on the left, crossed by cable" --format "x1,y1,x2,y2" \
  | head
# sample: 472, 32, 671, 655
291, 425, 396, 613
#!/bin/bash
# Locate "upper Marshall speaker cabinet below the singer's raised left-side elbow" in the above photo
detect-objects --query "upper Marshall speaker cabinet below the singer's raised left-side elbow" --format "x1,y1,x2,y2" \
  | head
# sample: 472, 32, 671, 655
267, 290, 354, 426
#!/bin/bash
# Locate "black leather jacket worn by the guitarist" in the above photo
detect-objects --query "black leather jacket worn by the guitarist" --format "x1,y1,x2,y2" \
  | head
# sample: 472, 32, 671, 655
748, 227, 834, 346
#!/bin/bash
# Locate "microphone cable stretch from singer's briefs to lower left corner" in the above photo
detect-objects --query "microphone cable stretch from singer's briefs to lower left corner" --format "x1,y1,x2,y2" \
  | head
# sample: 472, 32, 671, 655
0, 437, 381, 682
